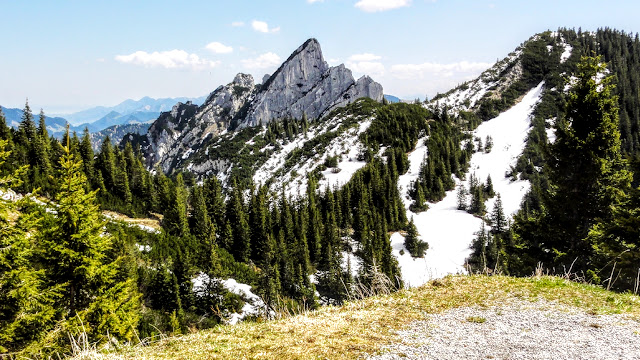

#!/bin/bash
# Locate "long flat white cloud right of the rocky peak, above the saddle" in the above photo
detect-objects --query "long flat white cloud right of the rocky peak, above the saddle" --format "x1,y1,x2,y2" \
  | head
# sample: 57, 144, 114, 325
391, 61, 493, 79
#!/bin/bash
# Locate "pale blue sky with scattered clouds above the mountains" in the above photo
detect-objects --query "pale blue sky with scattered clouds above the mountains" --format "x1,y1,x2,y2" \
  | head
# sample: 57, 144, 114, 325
0, 0, 640, 114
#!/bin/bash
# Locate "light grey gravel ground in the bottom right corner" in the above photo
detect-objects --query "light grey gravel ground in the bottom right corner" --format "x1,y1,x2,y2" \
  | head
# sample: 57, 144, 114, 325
369, 300, 640, 360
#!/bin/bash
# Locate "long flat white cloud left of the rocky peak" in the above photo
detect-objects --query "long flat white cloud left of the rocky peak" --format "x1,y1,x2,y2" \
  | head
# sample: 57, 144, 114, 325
115, 49, 217, 69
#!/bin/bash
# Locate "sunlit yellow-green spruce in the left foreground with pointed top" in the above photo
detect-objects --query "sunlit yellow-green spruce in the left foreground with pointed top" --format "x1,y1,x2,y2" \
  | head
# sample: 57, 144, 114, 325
40, 131, 139, 342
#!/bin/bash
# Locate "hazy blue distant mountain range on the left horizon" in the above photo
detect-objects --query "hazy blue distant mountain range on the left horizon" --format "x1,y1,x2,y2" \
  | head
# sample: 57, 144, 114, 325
0, 96, 206, 137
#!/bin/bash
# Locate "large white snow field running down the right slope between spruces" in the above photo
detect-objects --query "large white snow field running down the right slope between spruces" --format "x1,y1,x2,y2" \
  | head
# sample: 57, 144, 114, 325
391, 83, 543, 287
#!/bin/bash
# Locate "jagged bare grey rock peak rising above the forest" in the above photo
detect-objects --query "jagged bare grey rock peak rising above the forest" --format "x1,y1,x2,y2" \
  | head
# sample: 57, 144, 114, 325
141, 39, 383, 172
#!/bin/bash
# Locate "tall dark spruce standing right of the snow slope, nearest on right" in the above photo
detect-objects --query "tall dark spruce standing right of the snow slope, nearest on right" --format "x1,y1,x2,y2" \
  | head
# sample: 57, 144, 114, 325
541, 57, 631, 270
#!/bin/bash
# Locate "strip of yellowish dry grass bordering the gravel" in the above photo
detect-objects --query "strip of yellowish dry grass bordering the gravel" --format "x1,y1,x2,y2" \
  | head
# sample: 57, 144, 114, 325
94, 276, 640, 359
